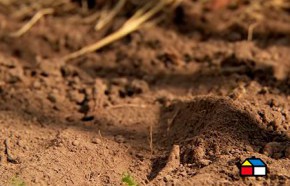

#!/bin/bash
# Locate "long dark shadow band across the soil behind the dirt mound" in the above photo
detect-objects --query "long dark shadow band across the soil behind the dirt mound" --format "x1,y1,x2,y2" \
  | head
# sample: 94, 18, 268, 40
75, 56, 290, 95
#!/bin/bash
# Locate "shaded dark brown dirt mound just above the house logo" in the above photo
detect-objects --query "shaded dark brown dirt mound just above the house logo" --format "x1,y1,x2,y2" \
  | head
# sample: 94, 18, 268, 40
163, 96, 289, 165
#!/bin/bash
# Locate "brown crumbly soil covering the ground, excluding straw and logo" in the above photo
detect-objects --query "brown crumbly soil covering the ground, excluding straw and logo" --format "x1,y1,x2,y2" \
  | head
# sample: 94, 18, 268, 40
0, 0, 290, 185
